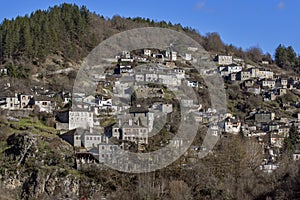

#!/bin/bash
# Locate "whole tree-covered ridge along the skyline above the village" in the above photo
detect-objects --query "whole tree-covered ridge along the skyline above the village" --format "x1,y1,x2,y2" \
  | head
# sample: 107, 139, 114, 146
0, 4, 300, 74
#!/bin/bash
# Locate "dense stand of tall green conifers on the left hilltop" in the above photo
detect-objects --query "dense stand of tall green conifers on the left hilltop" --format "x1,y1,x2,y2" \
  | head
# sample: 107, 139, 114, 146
0, 4, 92, 63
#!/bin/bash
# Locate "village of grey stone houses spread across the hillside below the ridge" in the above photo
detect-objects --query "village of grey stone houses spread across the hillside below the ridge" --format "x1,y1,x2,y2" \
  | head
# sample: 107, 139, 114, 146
0, 47, 300, 172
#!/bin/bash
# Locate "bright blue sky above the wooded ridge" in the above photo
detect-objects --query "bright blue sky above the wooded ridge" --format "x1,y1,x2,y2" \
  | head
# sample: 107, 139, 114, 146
0, 0, 300, 55
